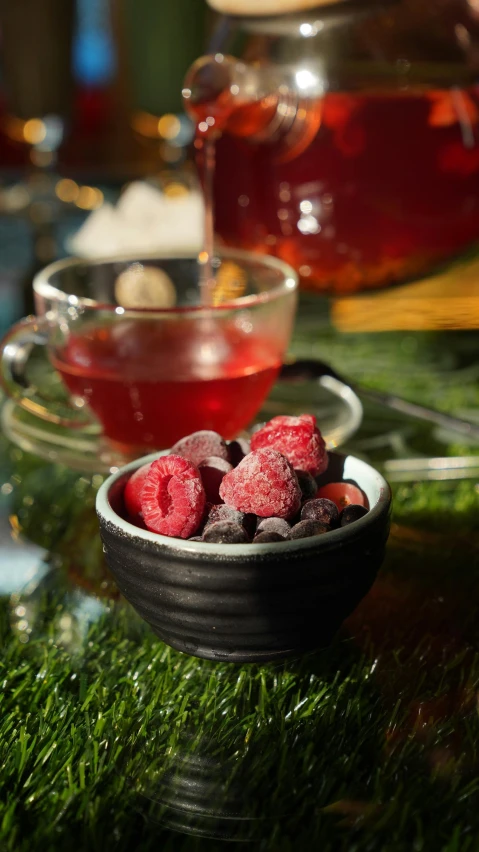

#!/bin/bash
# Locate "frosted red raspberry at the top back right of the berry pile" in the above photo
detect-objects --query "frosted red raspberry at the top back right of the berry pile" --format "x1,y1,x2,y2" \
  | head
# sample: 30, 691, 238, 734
251, 414, 328, 476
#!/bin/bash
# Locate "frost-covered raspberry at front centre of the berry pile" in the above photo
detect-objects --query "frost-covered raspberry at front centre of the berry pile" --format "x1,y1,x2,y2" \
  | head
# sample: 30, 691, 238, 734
220, 449, 301, 518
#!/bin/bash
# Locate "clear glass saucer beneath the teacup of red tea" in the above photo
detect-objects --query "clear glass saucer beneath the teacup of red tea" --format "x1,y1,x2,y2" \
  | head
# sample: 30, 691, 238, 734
0, 376, 363, 473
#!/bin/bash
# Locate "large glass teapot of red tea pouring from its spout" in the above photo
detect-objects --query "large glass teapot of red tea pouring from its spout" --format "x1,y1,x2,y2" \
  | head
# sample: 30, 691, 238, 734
183, 0, 479, 293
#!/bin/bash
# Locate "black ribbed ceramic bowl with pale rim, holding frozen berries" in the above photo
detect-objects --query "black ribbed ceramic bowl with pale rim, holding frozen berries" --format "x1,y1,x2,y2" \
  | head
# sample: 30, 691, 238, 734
96, 453, 391, 663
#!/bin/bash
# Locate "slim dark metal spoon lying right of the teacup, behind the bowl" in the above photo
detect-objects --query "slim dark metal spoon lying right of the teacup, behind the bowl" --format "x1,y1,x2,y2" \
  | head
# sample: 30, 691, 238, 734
281, 359, 479, 442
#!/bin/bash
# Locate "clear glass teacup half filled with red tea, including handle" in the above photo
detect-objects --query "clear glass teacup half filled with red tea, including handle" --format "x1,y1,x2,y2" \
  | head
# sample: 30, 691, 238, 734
2, 250, 297, 458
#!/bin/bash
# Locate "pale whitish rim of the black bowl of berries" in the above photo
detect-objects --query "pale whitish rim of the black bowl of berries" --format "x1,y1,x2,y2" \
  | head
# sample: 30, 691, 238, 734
96, 450, 391, 558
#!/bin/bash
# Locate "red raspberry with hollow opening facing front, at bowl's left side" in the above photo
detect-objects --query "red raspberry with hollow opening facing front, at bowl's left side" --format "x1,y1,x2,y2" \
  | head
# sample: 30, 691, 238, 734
141, 455, 206, 538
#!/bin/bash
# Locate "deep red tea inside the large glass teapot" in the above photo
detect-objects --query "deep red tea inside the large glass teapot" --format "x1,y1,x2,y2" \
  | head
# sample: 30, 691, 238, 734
189, 87, 479, 293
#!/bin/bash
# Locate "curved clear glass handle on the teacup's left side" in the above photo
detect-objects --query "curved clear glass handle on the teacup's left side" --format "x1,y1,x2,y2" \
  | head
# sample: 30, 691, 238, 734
0, 316, 94, 429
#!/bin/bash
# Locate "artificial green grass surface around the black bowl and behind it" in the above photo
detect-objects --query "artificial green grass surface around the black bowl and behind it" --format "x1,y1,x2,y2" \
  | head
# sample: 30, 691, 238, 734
0, 316, 479, 852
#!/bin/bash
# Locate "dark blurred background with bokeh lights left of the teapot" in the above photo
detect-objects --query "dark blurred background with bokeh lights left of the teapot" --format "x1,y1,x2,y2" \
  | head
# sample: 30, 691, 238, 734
0, 0, 214, 333
